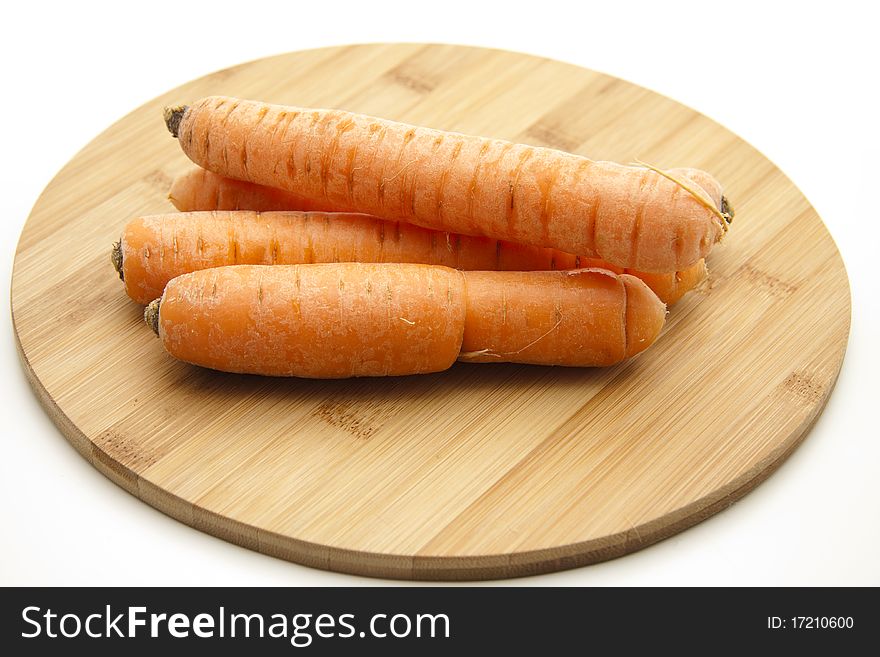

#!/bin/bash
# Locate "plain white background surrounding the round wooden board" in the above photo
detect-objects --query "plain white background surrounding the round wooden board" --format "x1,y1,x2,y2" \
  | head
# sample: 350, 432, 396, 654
0, 0, 880, 586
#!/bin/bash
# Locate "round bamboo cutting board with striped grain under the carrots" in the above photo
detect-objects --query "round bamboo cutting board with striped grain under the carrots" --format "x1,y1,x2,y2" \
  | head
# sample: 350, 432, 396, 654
12, 44, 850, 579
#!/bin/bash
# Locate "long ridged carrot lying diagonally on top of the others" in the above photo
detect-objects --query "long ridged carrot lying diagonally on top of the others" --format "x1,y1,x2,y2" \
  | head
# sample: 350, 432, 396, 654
165, 96, 732, 272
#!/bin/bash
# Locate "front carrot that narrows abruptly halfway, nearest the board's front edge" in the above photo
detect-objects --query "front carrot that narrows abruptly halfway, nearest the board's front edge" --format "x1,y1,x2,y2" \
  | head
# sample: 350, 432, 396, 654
144, 263, 665, 378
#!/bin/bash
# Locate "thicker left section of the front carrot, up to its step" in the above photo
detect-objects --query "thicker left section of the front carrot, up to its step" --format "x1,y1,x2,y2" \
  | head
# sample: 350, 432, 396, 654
158, 264, 465, 379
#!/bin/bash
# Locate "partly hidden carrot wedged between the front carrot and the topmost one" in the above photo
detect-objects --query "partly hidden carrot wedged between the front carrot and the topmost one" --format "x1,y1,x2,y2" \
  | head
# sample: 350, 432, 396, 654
112, 211, 705, 303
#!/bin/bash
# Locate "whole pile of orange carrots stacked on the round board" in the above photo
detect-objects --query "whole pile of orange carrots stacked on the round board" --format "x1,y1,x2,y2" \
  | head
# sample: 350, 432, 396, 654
111, 97, 732, 378
